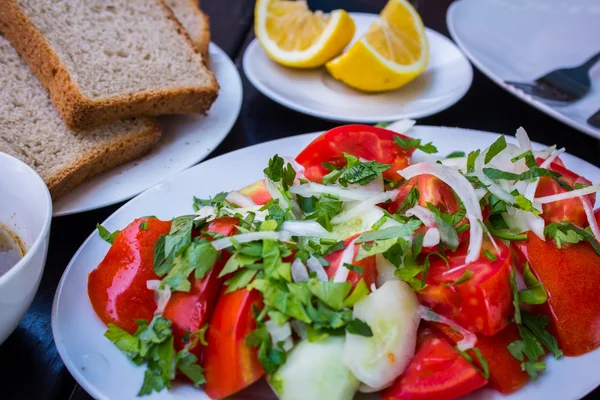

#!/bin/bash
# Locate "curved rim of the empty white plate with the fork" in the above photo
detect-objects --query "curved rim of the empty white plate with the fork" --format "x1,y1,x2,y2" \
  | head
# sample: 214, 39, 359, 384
446, 0, 600, 139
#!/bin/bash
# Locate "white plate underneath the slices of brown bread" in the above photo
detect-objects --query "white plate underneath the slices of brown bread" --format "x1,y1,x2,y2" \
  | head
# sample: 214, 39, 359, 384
54, 43, 242, 217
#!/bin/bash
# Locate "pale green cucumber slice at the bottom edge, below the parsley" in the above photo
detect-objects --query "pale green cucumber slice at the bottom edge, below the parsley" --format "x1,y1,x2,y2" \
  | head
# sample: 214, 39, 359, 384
269, 336, 360, 400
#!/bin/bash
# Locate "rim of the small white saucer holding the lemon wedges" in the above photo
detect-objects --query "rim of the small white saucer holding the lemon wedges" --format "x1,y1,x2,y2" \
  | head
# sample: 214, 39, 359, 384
242, 12, 473, 124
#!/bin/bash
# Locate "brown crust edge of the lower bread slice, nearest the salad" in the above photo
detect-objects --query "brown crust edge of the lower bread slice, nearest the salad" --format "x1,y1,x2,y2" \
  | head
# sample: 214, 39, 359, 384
46, 118, 161, 200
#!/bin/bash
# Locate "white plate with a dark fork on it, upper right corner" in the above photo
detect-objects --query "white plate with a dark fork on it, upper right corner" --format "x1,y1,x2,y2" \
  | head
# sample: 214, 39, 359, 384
446, 0, 600, 139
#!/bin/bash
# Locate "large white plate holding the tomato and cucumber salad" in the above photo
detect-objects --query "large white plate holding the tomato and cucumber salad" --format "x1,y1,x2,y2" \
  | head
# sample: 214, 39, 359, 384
52, 126, 600, 400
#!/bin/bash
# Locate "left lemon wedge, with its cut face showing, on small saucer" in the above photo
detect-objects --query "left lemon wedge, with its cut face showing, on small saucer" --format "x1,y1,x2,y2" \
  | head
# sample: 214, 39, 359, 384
254, 0, 356, 68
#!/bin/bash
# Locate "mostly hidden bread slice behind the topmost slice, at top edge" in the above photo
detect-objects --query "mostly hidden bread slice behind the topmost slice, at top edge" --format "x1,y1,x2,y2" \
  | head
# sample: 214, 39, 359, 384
165, 0, 210, 61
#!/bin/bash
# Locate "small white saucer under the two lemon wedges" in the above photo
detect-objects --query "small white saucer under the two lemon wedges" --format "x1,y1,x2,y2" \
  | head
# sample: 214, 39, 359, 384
243, 13, 473, 123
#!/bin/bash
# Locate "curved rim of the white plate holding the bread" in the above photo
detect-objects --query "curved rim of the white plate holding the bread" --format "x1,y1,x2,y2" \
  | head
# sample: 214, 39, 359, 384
52, 42, 244, 218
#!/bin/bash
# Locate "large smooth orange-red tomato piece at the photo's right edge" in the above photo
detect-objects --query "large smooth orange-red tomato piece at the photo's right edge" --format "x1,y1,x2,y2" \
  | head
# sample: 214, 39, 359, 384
513, 232, 600, 356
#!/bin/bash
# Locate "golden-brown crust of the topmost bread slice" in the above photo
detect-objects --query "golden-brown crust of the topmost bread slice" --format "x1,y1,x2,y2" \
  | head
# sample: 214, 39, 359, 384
0, 0, 219, 130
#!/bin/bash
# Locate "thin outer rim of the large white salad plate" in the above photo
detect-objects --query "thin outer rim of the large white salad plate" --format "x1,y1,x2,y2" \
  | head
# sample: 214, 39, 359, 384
51, 125, 600, 400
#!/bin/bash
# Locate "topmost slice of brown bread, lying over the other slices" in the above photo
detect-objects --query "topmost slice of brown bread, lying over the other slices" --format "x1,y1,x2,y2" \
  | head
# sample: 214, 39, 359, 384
0, 0, 218, 130
